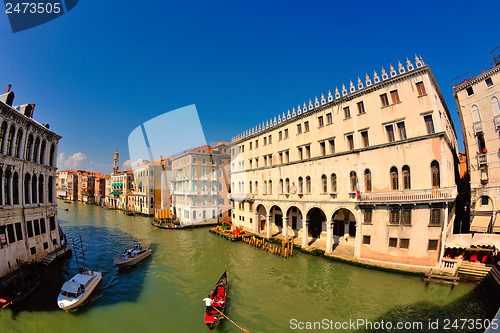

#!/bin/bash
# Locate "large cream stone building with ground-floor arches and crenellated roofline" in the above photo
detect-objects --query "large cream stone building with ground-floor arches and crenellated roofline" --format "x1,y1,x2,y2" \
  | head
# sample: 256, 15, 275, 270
230, 57, 458, 267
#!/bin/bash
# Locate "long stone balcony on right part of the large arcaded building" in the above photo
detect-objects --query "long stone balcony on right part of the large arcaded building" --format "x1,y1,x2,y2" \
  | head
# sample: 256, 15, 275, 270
359, 187, 457, 203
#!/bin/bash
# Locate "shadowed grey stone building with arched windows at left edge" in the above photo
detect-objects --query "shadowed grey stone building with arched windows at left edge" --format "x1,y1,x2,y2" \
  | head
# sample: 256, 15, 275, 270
0, 85, 61, 276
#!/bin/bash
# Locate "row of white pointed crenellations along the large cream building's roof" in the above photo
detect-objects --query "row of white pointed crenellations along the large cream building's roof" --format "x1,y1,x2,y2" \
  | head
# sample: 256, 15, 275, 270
231, 54, 425, 143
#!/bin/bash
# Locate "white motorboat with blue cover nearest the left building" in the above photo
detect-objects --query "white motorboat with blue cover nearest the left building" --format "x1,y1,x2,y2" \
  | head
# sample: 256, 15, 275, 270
57, 270, 102, 311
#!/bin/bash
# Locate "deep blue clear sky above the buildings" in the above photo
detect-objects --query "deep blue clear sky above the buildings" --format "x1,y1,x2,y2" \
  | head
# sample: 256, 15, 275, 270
0, 0, 500, 173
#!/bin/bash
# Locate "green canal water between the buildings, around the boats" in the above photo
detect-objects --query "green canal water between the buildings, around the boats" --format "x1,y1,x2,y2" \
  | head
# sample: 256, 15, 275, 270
0, 201, 497, 333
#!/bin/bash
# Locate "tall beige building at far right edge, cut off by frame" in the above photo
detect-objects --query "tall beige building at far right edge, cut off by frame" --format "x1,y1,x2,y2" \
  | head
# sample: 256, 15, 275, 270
453, 48, 500, 233
